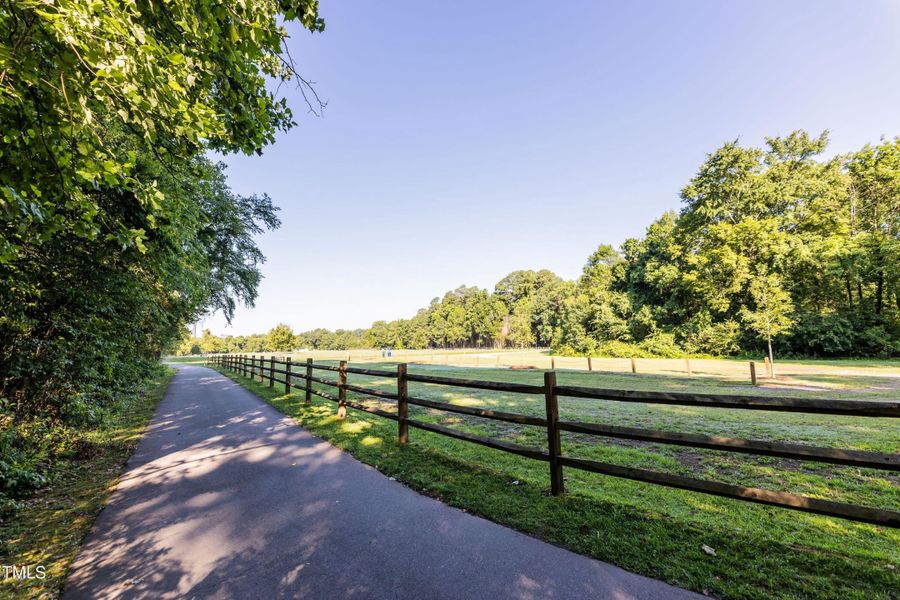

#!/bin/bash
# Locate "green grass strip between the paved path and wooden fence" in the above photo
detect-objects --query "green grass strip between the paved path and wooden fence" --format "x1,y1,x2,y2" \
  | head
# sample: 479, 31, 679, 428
221, 370, 900, 599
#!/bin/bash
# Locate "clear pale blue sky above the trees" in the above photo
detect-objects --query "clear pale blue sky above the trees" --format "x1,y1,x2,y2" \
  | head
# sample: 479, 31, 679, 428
201, 0, 900, 334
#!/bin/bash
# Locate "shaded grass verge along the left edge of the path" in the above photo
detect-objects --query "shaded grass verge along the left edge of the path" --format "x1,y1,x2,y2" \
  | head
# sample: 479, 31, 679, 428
0, 368, 175, 600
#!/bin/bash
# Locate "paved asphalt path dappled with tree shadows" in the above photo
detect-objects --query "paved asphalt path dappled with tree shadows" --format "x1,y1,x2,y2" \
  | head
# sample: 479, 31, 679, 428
63, 366, 697, 600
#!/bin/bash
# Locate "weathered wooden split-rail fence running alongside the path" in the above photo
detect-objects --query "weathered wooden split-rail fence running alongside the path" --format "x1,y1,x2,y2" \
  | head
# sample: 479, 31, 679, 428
209, 355, 900, 527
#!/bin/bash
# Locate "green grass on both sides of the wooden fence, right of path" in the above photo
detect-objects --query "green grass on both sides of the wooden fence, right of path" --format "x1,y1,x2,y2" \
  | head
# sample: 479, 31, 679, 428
213, 355, 900, 598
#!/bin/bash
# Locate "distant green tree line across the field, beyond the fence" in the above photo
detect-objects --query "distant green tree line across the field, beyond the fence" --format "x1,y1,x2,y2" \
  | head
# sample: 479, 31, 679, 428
181, 131, 900, 357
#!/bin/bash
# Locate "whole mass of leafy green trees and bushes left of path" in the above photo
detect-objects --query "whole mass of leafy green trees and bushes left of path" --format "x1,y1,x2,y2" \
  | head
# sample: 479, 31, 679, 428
0, 0, 323, 498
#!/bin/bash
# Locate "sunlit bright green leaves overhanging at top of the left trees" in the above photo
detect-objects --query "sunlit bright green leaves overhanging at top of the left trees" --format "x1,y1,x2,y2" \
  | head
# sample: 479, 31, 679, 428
0, 0, 322, 262
